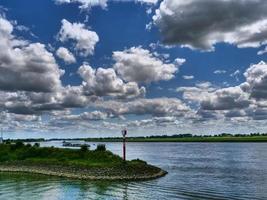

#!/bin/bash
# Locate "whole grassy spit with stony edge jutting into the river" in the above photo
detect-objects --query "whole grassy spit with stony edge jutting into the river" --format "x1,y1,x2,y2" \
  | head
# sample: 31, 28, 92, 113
0, 142, 168, 180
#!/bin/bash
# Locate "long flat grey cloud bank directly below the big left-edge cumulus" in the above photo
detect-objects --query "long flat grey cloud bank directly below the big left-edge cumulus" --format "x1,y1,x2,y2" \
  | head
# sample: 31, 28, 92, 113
0, 86, 98, 115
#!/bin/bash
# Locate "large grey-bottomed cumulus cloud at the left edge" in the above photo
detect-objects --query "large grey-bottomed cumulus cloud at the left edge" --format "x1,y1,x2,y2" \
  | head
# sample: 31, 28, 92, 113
0, 17, 64, 92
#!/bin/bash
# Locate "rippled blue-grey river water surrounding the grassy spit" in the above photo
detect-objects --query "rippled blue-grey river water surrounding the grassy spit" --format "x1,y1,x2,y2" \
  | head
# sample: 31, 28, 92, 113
0, 142, 267, 200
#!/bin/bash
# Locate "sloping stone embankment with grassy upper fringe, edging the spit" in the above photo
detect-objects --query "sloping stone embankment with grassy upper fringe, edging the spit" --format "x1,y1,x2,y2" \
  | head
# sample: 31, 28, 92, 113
0, 162, 167, 180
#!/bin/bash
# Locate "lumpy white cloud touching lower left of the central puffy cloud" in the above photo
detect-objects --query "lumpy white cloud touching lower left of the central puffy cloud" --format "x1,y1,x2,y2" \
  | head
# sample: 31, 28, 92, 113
78, 64, 145, 98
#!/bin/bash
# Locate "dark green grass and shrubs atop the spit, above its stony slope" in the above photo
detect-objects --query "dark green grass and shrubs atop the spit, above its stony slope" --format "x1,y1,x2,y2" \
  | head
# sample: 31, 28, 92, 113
0, 143, 138, 167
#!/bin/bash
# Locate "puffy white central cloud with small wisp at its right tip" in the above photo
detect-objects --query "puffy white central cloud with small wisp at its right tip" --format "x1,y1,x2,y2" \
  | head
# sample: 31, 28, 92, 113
113, 47, 185, 83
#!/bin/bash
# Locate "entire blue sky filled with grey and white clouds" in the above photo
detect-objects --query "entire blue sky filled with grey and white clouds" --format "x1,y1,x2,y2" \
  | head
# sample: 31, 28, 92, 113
0, 0, 267, 138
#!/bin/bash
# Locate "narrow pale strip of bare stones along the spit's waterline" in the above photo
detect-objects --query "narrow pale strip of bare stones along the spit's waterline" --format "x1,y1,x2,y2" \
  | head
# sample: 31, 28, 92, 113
0, 165, 168, 181
